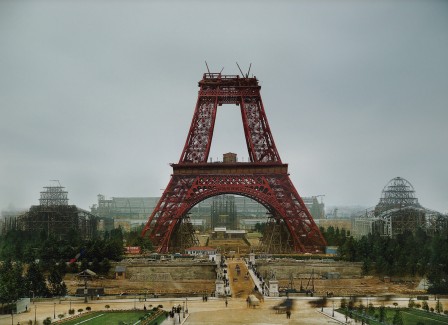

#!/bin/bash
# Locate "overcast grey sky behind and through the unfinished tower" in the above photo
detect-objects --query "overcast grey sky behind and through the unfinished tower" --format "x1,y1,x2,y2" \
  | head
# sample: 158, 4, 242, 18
0, 0, 448, 212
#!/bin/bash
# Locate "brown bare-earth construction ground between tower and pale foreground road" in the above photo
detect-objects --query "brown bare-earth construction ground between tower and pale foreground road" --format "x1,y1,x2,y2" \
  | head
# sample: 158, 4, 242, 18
66, 257, 424, 297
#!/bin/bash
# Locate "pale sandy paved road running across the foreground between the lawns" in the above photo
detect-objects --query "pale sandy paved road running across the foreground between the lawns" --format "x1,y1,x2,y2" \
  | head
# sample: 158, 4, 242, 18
0, 297, 448, 325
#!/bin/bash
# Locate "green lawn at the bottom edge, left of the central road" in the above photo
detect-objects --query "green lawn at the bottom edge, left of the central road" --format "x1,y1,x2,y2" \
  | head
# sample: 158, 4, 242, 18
61, 311, 160, 325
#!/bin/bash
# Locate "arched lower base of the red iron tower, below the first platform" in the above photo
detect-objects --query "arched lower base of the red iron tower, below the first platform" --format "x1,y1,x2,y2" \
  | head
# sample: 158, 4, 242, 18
143, 163, 325, 253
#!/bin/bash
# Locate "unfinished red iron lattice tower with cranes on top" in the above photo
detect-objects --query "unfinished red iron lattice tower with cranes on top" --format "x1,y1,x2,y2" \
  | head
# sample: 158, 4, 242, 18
142, 73, 326, 253
